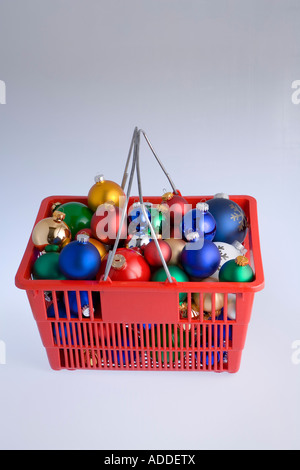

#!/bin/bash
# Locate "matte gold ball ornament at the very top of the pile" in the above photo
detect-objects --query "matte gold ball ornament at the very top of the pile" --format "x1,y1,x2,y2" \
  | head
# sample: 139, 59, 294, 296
88, 175, 125, 212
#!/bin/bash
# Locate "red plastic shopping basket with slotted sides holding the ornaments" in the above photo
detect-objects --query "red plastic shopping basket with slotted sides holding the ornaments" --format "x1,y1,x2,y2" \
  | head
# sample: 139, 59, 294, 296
16, 127, 264, 373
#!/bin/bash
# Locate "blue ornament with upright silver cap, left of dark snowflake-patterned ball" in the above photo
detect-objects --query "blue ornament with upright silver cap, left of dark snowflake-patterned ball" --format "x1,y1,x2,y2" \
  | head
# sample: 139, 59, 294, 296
181, 202, 216, 241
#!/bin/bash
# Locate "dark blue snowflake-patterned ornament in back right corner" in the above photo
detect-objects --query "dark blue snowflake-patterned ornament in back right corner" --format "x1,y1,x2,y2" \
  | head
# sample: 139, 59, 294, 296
207, 193, 248, 244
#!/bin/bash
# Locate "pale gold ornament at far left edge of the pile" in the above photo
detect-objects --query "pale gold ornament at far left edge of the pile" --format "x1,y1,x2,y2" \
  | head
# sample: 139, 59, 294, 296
32, 211, 71, 251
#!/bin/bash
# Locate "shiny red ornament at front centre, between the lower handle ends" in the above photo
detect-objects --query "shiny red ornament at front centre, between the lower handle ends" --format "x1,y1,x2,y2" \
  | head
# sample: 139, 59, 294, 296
99, 248, 151, 282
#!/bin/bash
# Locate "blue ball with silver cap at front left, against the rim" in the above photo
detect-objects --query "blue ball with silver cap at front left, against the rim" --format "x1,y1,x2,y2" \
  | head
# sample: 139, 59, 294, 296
59, 234, 101, 280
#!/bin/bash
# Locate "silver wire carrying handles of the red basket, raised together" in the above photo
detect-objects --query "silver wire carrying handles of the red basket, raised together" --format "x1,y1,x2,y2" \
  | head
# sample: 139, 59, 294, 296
103, 127, 178, 283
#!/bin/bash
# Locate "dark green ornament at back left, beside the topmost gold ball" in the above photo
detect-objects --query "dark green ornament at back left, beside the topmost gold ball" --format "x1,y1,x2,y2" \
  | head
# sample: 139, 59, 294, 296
55, 202, 93, 240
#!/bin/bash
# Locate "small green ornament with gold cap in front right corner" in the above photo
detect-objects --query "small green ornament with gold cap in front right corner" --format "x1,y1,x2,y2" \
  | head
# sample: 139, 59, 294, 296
219, 256, 254, 282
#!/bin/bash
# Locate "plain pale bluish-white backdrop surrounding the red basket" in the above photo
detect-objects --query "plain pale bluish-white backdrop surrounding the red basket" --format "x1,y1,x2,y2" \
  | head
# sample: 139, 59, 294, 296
0, 0, 300, 450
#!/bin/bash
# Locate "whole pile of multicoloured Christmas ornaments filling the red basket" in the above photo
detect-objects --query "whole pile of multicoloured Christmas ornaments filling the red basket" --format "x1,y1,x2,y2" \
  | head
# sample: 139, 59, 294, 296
32, 175, 254, 316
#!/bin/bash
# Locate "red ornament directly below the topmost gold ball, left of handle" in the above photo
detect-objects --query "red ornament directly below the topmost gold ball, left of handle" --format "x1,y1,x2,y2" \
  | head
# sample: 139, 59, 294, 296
91, 202, 127, 245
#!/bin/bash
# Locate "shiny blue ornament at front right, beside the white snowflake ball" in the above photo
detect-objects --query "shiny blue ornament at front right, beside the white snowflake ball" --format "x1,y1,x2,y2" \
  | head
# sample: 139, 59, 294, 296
181, 240, 221, 279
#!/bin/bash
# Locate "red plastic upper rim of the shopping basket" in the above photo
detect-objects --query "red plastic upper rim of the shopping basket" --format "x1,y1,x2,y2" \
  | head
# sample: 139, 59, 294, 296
15, 195, 265, 293
